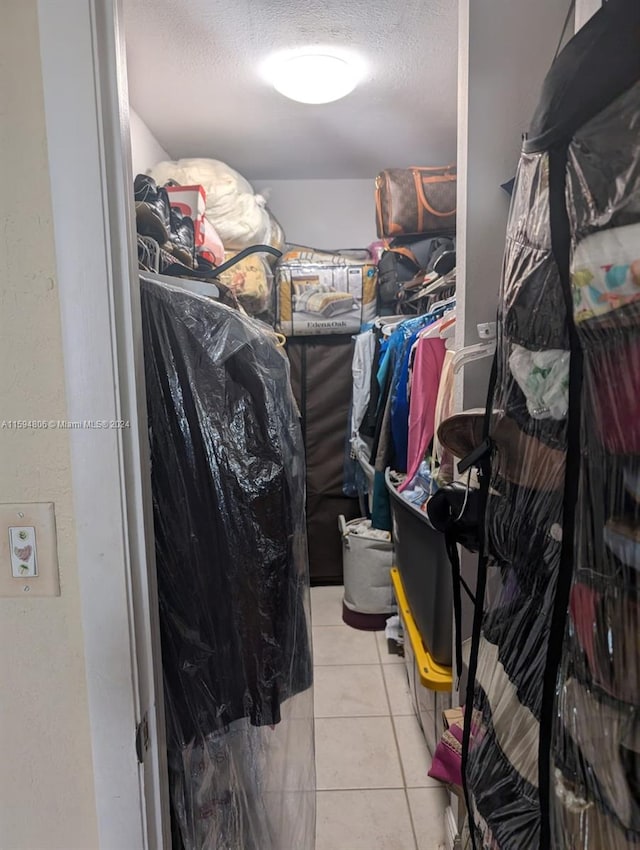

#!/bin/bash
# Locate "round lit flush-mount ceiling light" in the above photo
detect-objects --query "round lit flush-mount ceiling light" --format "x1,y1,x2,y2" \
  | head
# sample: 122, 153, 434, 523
264, 48, 363, 104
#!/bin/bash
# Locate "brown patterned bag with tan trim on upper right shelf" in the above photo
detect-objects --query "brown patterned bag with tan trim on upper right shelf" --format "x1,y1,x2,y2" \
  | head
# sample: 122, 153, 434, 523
376, 166, 457, 238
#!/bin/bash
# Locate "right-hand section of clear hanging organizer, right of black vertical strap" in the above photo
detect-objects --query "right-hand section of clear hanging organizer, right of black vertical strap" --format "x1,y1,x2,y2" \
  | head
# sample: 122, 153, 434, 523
549, 8, 640, 850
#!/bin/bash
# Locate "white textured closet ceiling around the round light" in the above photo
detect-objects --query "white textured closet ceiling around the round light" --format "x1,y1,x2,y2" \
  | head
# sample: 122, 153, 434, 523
124, 0, 457, 179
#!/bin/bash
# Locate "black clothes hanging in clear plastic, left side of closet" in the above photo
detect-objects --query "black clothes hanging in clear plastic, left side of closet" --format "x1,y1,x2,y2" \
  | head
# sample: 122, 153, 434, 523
141, 278, 315, 850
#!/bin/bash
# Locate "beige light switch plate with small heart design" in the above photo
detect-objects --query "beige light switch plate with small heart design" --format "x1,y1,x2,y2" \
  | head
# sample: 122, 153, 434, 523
0, 502, 60, 599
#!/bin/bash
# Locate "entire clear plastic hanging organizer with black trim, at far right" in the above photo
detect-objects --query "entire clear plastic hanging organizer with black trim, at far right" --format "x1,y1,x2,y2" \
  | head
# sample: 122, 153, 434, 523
466, 0, 640, 850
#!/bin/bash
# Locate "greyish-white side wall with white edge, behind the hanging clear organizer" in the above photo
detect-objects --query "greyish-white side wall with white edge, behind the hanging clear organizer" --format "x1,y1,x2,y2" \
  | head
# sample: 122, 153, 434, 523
456, 0, 568, 407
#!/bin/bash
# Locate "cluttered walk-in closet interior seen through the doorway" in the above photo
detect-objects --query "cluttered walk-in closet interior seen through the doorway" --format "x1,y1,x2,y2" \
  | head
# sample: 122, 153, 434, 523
121, 0, 640, 850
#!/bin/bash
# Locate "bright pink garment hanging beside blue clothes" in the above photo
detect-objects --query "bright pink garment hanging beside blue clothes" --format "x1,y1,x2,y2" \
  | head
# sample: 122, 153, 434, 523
398, 337, 446, 491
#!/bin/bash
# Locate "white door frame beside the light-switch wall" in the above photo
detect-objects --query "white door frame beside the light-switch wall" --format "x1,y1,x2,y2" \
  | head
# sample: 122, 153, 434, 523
37, 0, 171, 850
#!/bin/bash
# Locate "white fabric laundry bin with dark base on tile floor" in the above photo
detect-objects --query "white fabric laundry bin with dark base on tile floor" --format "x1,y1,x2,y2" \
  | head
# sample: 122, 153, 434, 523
338, 516, 396, 631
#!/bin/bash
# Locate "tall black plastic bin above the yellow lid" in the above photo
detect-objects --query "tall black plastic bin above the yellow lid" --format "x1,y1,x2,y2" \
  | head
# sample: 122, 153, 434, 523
385, 470, 453, 667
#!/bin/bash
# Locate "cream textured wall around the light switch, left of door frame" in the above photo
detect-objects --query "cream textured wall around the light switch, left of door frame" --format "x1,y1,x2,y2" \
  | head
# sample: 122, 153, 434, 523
0, 0, 98, 850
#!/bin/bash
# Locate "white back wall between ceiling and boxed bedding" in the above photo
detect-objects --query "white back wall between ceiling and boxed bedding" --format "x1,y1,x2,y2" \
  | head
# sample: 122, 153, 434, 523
253, 175, 377, 249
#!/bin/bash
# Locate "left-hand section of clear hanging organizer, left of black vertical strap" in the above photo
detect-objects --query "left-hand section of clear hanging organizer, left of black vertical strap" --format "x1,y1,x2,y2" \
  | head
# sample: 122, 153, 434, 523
465, 144, 568, 850
